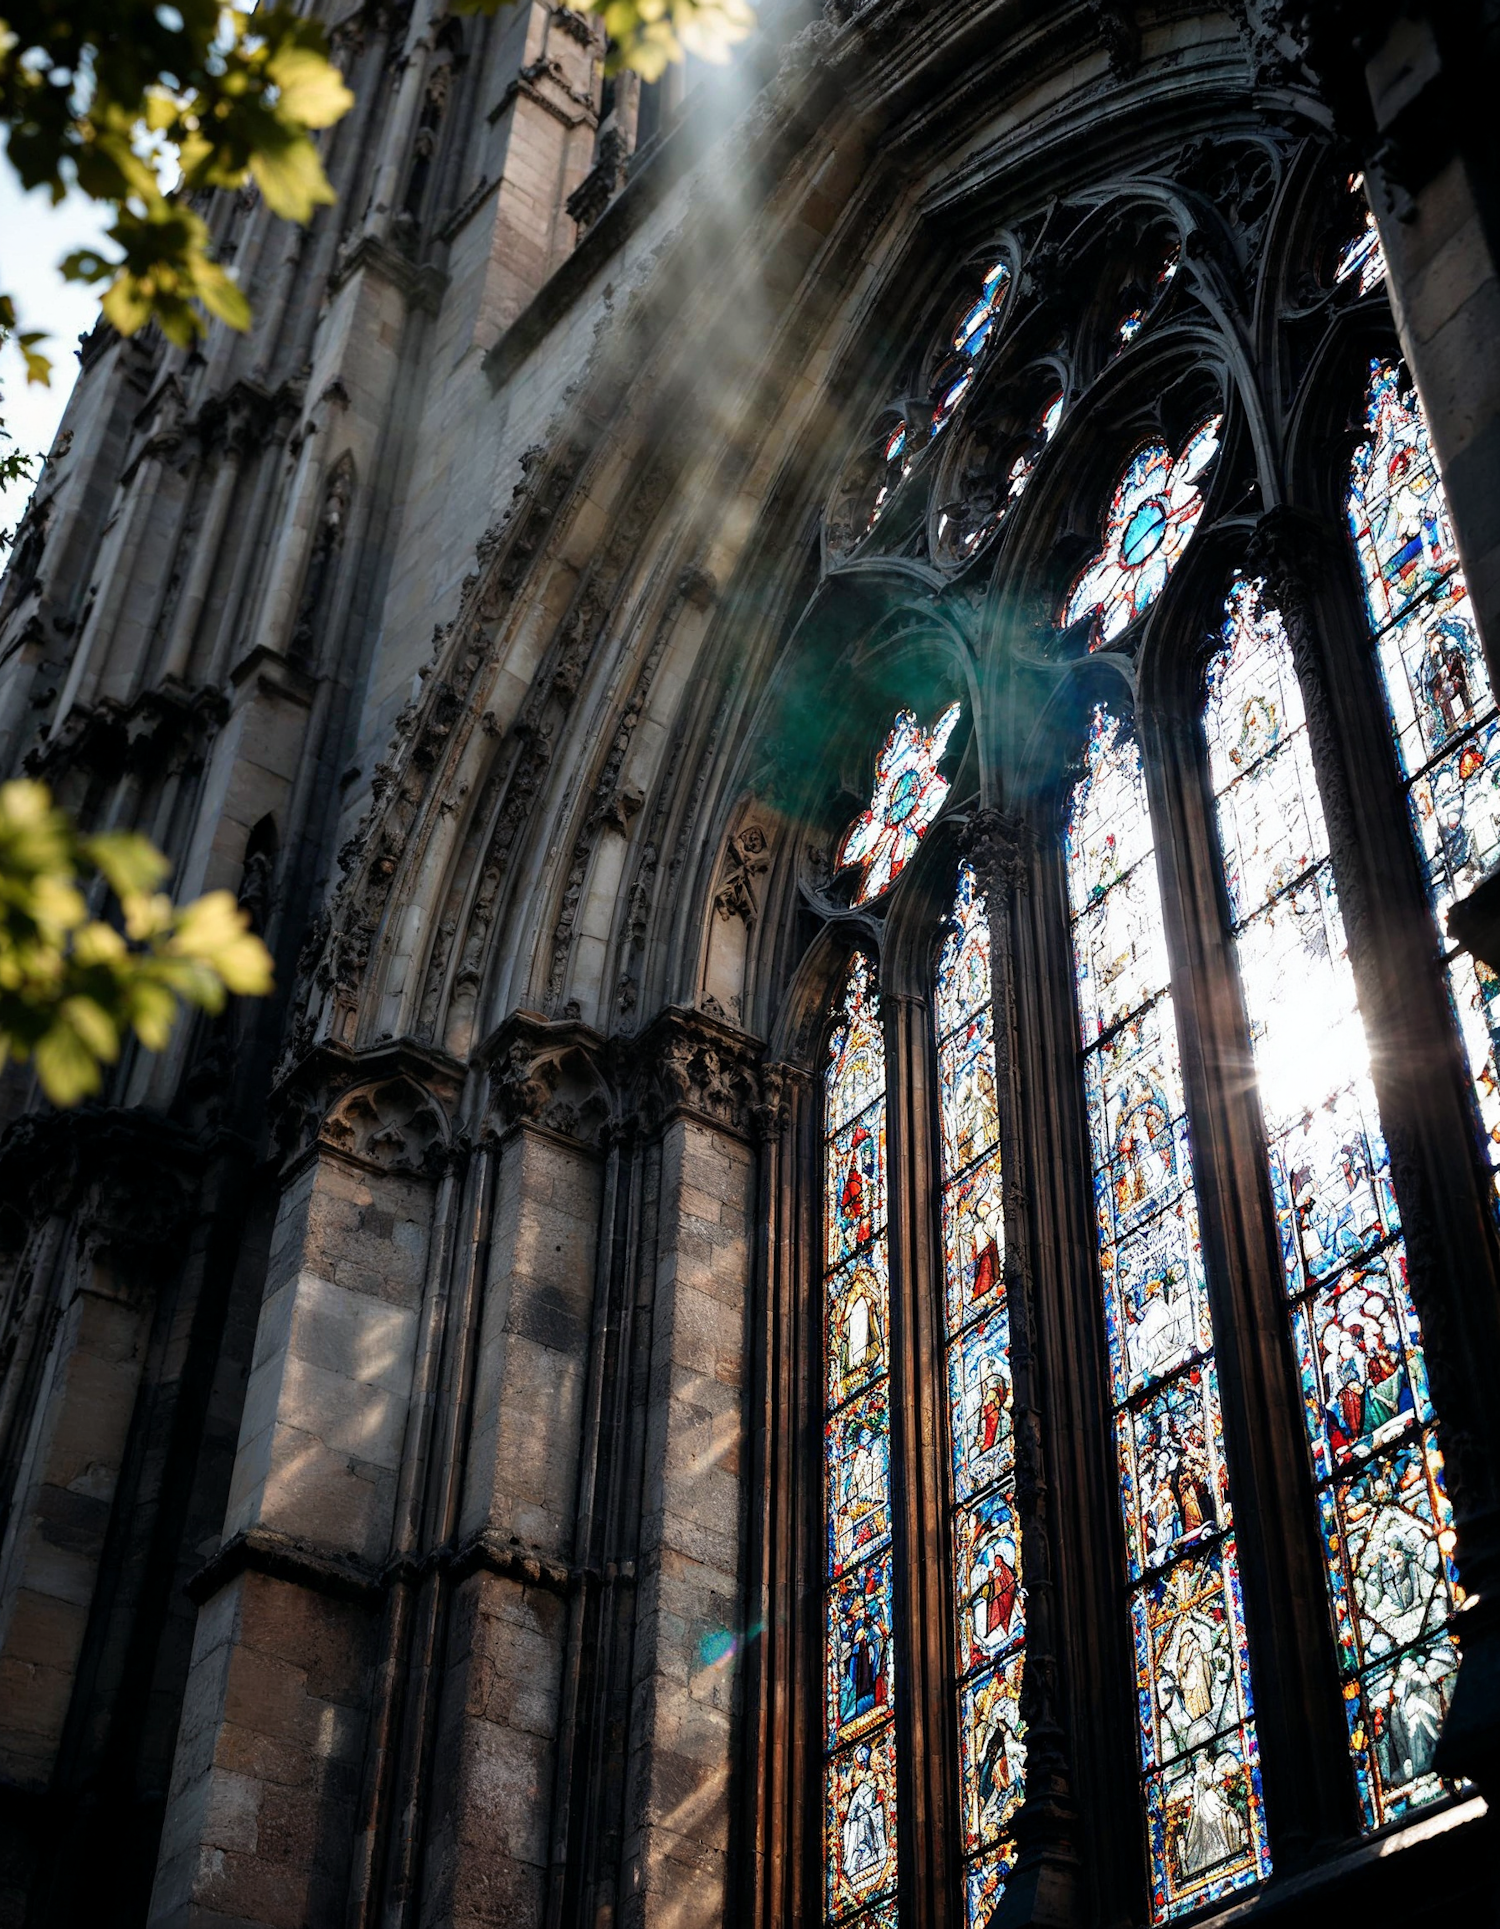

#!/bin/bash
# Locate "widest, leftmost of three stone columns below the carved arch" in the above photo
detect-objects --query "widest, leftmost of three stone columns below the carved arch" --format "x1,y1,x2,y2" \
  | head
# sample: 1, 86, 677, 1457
148, 1049, 455, 1929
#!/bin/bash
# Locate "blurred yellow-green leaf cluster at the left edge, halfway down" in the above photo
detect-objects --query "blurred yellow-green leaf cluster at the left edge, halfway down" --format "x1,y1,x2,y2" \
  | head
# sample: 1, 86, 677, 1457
0, 781, 272, 1105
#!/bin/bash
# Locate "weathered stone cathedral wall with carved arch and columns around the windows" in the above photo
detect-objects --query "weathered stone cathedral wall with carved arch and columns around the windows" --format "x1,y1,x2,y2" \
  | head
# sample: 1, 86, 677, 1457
0, 0, 1500, 1929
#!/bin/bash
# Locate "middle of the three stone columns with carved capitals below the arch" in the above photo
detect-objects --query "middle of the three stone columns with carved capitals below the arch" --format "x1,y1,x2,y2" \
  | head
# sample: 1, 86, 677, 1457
411, 1017, 607, 1929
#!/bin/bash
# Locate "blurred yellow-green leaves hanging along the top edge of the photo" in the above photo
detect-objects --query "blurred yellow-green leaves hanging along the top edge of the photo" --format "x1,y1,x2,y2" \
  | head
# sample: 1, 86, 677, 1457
0, 0, 756, 382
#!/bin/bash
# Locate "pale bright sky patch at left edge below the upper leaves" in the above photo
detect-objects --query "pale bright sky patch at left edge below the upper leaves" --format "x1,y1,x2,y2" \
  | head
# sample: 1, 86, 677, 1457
0, 158, 112, 540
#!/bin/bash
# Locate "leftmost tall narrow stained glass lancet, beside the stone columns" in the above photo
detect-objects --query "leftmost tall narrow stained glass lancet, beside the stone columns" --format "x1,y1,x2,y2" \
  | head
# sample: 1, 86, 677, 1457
823, 953, 897, 1929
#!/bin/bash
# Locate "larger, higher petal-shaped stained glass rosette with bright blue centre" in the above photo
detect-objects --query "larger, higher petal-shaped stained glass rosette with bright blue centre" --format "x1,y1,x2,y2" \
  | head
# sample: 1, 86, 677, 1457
1058, 415, 1224, 650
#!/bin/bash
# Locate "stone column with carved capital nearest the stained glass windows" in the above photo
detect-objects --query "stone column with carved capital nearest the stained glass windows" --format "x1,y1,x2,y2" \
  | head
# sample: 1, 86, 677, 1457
619, 1011, 758, 1929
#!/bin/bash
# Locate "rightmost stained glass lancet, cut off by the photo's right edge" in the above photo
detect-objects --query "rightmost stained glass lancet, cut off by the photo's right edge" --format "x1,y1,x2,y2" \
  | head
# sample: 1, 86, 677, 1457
1346, 361, 1500, 1182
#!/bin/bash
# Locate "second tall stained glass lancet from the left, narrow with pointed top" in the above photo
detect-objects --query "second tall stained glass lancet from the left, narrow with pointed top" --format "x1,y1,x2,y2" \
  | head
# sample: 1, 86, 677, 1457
937, 864, 1026, 1929
